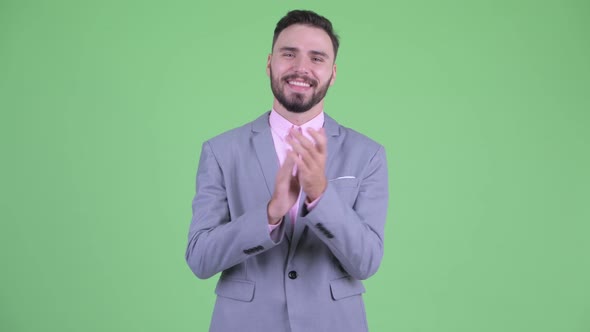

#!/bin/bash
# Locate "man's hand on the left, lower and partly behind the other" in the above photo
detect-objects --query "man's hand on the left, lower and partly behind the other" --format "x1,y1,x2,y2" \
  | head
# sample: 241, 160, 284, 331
267, 151, 300, 225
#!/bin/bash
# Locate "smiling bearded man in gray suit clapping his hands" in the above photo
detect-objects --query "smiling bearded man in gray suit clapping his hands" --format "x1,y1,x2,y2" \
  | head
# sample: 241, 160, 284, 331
186, 11, 388, 332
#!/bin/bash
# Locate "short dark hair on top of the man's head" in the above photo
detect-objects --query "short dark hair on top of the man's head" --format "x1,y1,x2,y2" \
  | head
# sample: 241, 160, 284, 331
272, 10, 340, 60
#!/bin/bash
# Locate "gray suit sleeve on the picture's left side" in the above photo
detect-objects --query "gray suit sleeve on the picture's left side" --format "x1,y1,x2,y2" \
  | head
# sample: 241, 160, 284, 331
185, 142, 284, 279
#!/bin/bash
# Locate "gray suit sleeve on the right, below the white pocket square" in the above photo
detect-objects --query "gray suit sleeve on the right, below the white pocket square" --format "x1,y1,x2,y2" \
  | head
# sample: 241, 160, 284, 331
301, 147, 389, 280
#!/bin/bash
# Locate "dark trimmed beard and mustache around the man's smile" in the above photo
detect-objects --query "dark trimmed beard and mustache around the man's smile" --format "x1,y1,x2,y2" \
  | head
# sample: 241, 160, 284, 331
270, 69, 333, 113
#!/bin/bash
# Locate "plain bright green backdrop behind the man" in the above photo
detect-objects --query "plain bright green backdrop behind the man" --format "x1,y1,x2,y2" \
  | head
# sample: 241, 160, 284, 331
0, 0, 590, 332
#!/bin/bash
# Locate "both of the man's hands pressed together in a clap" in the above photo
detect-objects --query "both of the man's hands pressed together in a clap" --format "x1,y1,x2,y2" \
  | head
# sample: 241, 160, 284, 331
268, 128, 328, 224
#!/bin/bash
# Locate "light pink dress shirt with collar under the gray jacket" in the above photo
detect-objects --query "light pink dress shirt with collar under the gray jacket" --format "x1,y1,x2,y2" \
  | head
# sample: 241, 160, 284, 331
268, 109, 324, 233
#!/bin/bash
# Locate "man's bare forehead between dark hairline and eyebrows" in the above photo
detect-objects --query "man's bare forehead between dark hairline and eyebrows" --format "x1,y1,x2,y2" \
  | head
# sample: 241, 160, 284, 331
273, 24, 334, 58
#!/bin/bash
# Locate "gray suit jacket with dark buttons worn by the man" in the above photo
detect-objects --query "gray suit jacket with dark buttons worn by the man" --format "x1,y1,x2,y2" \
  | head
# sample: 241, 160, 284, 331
186, 112, 388, 332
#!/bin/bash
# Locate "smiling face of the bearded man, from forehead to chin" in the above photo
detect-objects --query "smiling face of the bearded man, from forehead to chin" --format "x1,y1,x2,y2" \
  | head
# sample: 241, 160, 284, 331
267, 24, 336, 113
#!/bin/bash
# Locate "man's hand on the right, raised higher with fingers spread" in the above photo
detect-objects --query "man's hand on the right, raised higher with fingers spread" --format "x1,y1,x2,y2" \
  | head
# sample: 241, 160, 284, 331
287, 128, 328, 202
